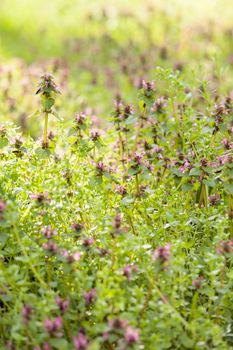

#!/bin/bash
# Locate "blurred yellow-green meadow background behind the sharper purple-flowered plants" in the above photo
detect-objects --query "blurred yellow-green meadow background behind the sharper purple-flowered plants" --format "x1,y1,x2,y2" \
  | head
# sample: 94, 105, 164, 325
0, 0, 233, 134
